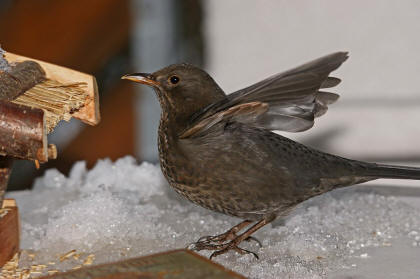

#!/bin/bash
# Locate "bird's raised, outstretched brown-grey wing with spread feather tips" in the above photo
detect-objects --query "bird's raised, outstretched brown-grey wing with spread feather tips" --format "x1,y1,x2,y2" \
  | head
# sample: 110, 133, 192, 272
181, 52, 348, 137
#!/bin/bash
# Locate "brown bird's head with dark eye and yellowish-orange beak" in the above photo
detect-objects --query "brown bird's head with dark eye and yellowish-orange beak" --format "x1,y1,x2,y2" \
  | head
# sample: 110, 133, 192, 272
122, 64, 225, 121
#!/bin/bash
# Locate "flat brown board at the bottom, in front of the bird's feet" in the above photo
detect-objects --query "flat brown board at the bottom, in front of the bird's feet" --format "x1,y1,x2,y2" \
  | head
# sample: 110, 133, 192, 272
42, 249, 245, 279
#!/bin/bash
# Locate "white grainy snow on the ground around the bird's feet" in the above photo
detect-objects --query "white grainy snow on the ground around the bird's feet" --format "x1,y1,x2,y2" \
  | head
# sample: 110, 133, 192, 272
7, 157, 420, 278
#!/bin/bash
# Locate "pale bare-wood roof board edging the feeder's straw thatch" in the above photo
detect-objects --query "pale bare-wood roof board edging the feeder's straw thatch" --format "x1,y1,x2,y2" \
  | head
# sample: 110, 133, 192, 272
5, 52, 100, 125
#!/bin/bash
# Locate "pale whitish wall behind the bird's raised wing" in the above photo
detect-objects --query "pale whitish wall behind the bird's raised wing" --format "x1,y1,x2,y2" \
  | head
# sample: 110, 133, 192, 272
205, 0, 420, 161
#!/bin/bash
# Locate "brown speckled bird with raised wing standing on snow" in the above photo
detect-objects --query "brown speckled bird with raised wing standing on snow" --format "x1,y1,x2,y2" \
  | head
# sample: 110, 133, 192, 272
122, 52, 420, 258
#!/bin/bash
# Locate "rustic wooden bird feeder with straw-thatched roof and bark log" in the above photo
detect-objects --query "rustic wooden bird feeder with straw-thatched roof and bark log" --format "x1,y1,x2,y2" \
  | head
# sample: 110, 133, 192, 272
0, 49, 100, 267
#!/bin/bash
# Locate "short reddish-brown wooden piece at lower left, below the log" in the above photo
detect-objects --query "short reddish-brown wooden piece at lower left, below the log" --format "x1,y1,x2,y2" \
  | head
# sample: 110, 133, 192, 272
0, 199, 19, 267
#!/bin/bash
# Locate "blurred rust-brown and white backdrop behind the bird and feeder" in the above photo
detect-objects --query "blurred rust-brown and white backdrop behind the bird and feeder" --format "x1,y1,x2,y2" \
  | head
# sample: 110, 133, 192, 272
0, 0, 420, 190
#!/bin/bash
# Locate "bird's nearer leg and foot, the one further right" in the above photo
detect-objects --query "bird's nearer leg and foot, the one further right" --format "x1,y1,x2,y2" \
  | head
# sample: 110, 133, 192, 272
210, 216, 275, 259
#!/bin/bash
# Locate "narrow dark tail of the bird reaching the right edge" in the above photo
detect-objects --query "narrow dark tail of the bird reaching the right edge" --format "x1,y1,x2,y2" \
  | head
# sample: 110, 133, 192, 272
367, 164, 420, 180
